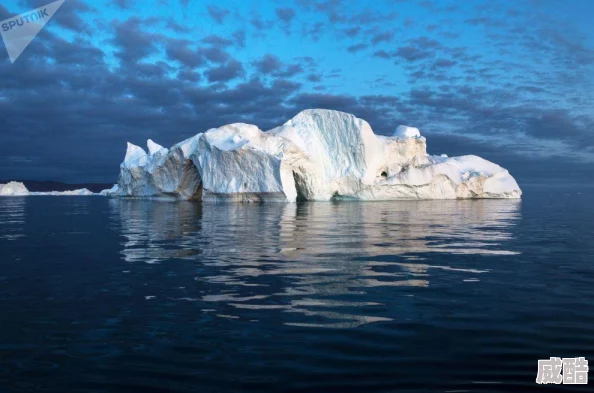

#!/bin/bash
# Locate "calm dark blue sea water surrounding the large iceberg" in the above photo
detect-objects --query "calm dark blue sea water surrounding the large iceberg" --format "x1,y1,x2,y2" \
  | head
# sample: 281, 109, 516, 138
0, 187, 594, 392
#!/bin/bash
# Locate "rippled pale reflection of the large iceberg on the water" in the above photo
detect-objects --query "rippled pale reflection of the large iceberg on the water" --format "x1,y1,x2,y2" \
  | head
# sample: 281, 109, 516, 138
110, 199, 520, 327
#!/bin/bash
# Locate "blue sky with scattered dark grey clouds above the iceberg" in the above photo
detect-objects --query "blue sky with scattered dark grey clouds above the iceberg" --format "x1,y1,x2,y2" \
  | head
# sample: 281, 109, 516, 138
0, 0, 594, 185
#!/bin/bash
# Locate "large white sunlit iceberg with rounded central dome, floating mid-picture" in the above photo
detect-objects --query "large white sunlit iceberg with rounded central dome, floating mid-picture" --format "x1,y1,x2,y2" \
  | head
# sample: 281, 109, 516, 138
110, 109, 522, 202
